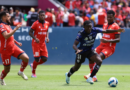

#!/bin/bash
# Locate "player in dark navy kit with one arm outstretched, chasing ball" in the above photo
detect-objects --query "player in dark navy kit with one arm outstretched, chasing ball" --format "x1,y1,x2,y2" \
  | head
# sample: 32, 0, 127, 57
65, 21, 124, 84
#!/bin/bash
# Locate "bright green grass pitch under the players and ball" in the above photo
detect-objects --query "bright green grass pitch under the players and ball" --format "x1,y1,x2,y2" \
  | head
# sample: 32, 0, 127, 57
0, 65, 130, 90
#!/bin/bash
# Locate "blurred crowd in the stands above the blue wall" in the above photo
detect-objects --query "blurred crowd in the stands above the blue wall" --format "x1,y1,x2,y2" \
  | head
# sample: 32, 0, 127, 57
0, 0, 130, 28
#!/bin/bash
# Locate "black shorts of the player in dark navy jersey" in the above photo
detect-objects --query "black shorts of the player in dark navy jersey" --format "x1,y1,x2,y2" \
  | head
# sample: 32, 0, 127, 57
75, 50, 97, 64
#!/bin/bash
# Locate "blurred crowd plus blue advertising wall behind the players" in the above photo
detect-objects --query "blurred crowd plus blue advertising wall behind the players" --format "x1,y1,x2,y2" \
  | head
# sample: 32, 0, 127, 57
0, 0, 130, 64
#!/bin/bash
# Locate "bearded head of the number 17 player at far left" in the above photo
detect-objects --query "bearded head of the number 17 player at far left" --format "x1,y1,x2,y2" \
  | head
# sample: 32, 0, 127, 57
0, 11, 11, 24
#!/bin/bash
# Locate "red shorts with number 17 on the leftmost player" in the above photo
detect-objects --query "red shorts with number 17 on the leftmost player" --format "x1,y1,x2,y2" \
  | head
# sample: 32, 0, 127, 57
1, 45, 24, 66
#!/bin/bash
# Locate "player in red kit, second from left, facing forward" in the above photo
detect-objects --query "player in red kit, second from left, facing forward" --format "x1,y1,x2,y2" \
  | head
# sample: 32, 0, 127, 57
29, 11, 49, 78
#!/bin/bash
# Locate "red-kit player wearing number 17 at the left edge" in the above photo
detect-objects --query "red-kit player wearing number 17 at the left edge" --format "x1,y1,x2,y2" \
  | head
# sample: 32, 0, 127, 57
0, 12, 29, 85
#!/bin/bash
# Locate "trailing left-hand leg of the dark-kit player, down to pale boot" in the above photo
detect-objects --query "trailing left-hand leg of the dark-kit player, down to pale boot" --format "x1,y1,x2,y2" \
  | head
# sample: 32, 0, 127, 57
65, 54, 85, 84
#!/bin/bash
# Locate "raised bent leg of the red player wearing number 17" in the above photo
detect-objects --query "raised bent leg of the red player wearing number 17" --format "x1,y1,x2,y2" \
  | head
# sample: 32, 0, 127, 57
12, 45, 29, 80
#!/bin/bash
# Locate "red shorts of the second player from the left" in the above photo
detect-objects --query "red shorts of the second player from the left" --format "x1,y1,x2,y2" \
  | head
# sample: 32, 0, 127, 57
32, 44, 48, 58
